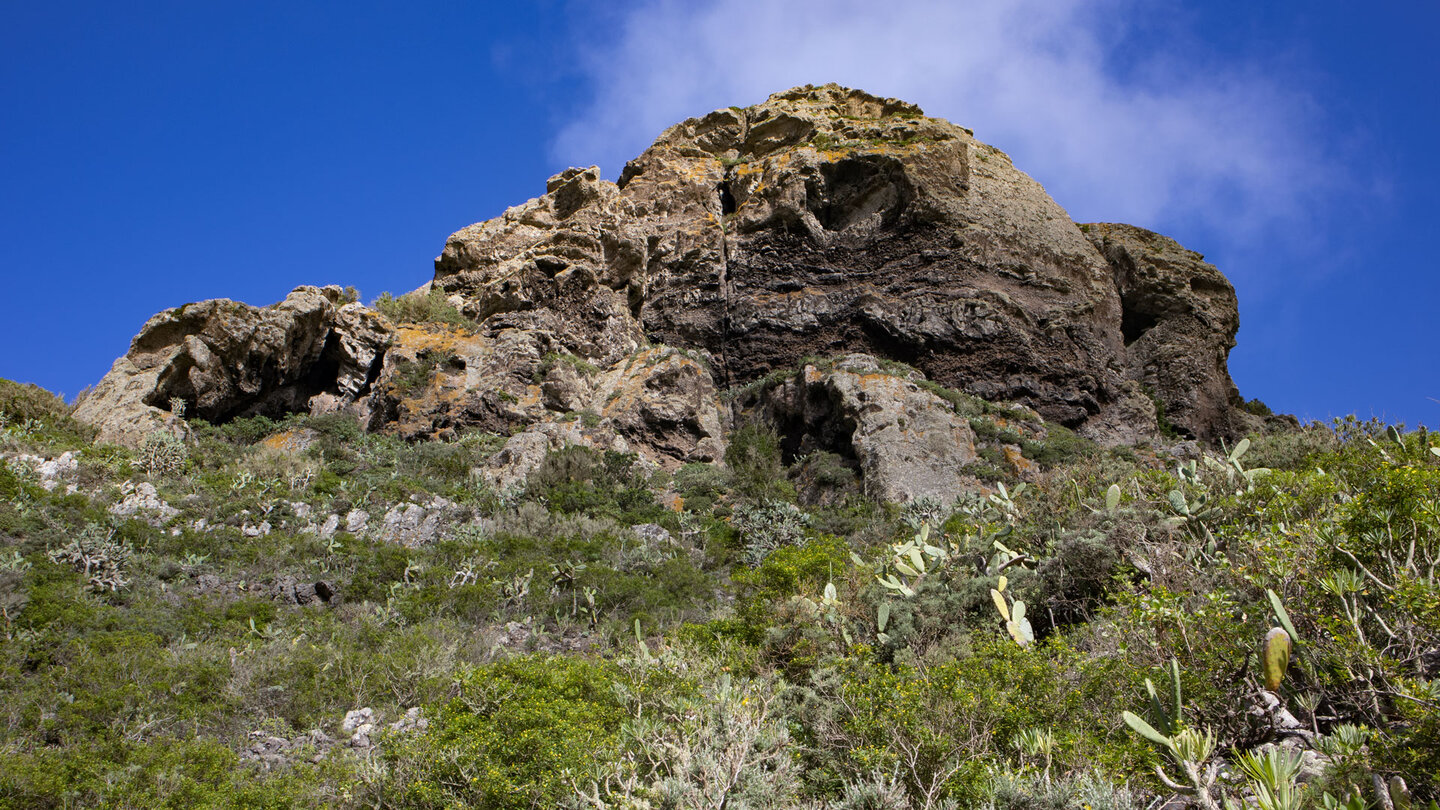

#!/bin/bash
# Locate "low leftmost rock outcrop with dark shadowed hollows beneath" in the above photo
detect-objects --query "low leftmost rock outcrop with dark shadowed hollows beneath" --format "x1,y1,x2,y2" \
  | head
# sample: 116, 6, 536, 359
75, 287, 390, 445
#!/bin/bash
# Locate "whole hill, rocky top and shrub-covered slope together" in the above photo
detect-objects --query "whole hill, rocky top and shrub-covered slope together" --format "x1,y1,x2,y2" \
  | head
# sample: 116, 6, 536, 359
0, 85, 1440, 810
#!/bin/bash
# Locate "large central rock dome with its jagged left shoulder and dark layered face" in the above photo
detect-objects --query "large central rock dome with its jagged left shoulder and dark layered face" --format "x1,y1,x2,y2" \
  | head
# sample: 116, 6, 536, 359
435, 85, 1155, 438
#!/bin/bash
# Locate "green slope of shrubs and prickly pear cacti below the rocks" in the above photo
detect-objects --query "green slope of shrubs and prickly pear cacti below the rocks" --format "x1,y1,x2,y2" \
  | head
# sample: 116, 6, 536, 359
0, 382, 1440, 810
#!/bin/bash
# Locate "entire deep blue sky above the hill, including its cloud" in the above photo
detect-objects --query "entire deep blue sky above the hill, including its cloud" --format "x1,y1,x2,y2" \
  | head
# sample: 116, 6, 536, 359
0, 0, 1440, 427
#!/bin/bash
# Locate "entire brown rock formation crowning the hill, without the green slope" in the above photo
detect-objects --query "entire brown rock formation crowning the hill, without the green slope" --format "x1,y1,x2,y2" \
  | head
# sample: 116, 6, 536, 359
76, 85, 1259, 500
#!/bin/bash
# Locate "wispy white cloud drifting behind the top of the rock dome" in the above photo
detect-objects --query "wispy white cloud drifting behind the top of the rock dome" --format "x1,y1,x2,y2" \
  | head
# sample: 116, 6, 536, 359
554, 0, 1339, 244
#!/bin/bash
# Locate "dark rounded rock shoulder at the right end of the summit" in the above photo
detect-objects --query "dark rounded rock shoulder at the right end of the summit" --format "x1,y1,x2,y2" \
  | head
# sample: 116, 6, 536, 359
1083, 223, 1257, 442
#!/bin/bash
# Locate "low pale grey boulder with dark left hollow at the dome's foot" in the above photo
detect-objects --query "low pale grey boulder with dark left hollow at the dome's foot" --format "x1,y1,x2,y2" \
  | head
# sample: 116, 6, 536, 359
760, 355, 976, 502
